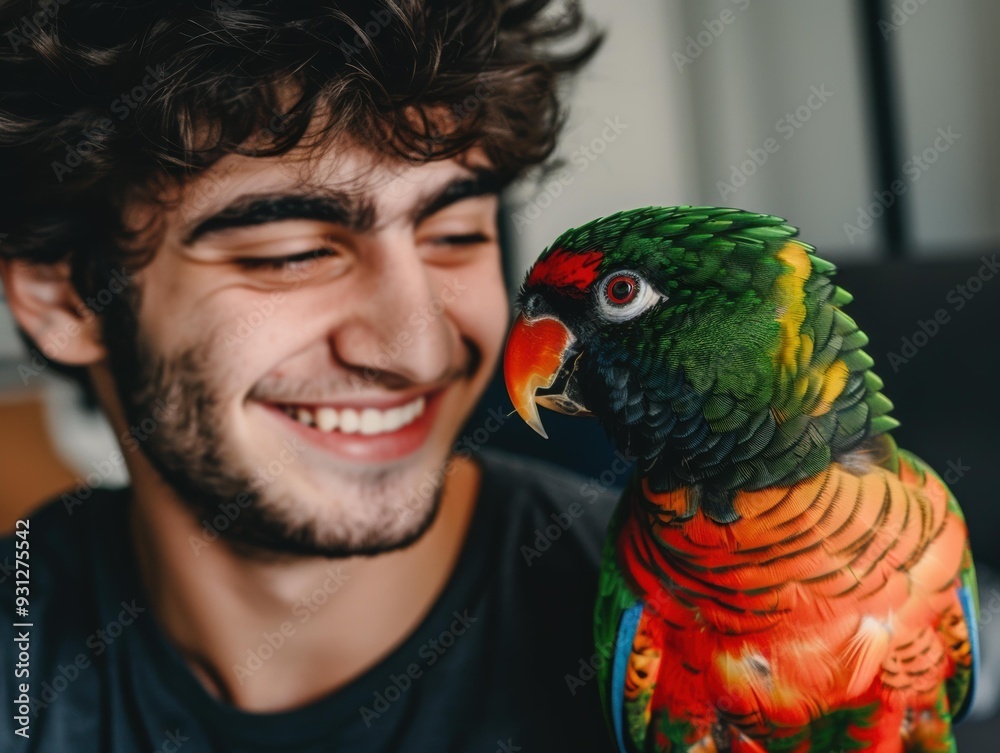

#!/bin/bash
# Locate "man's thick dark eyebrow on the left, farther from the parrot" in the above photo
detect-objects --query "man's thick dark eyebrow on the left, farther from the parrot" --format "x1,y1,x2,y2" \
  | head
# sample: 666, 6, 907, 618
184, 192, 375, 246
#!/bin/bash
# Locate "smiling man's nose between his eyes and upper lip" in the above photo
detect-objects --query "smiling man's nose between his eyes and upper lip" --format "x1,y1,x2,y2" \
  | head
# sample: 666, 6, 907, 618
331, 242, 456, 384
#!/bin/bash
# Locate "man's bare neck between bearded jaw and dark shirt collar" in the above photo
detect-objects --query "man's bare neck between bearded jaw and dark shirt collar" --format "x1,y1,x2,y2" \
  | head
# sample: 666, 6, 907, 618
131, 458, 480, 712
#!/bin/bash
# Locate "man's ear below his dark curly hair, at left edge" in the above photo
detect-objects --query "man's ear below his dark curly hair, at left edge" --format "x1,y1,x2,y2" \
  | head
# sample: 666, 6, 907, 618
0, 258, 106, 366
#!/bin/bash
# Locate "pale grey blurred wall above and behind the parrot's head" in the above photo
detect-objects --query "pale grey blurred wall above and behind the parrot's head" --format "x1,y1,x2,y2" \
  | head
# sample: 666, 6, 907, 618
512, 0, 1000, 264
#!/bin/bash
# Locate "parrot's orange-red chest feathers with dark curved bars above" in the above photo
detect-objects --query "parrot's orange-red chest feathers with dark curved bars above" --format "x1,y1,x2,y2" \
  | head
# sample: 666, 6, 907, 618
618, 461, 968, 724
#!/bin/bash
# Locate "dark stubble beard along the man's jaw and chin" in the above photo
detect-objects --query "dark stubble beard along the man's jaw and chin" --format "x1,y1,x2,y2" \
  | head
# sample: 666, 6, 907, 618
103, 296, 448, 560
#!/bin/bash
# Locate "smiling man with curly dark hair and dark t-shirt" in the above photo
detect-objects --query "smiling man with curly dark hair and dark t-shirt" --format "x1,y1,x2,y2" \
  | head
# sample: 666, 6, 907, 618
0, 0, 610, 753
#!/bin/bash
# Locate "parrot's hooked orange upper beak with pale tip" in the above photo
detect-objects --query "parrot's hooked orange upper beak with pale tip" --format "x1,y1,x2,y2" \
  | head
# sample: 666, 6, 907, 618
503, 314, 576, 439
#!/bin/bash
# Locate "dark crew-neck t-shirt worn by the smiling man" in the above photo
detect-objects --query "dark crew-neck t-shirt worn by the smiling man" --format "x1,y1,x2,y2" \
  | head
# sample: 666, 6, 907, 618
0, 452, 615, 753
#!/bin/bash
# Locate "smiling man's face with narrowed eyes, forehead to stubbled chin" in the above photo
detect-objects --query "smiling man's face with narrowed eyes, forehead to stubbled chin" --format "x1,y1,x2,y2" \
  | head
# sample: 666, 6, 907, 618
112, 147, 507, 557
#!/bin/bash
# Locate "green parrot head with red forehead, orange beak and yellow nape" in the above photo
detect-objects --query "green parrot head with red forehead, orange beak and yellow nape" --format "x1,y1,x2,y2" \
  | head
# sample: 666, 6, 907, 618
504, 207, 896, 500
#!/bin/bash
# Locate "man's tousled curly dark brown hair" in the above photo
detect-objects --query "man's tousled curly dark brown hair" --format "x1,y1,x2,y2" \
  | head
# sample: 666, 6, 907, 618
0, 0, 601, 394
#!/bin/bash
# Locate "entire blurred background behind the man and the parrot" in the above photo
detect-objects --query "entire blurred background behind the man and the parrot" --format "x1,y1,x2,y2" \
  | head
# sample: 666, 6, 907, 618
0, 0, 1000, 740
